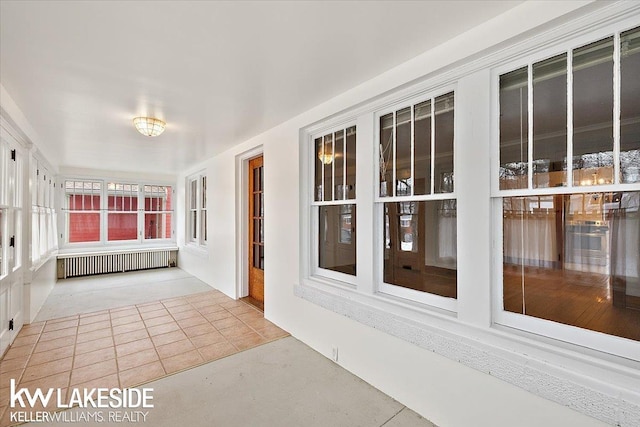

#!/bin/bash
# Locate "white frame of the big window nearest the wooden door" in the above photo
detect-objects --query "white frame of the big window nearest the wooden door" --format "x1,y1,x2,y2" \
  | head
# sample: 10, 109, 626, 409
307, 120, 359, 288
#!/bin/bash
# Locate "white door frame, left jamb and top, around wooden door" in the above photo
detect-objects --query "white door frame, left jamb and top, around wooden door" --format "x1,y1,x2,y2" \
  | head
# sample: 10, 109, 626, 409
235, 145, 264, 299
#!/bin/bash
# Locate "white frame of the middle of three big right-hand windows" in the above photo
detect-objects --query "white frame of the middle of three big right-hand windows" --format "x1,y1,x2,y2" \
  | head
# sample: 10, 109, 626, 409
373, 88, 459, 314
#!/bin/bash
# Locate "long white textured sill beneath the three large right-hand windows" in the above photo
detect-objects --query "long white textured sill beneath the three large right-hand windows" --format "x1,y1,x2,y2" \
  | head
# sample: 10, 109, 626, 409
294, 280, 640, 425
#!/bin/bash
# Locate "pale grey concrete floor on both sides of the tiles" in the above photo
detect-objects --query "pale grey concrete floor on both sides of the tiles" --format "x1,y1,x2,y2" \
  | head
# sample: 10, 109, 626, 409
21, 269, 434, 427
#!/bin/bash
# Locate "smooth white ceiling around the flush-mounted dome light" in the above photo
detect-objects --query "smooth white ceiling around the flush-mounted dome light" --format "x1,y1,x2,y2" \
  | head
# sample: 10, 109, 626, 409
0, 0, 521, 173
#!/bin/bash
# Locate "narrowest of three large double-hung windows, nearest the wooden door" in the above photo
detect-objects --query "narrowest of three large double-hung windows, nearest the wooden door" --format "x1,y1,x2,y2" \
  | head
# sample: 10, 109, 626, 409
312, 126, 356, 281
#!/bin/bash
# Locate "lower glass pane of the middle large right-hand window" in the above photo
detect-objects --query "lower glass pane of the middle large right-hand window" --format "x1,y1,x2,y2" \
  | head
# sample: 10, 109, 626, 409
383, 200, 457, 298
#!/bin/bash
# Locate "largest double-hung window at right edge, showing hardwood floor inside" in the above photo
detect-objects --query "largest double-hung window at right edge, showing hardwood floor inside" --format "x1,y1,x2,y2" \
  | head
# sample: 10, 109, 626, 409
494, 28, 640, 357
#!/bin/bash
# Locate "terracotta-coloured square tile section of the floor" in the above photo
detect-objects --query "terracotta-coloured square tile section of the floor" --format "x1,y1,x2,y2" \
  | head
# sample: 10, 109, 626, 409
0, 290, 288, 427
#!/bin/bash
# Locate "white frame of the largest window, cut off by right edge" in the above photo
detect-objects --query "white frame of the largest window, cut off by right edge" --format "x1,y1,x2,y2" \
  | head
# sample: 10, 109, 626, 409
491, 19, 640, 361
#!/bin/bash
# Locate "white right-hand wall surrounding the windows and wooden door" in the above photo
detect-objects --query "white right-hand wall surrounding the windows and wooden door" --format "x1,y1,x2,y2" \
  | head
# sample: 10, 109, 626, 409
178, 1, 636, 427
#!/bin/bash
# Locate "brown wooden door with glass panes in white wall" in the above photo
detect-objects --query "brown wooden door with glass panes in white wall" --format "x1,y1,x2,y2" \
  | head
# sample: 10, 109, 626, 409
248, 156, 264, 303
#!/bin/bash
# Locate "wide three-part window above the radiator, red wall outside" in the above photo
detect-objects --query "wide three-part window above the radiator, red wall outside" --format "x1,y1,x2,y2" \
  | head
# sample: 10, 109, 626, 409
63, 180, 173, 244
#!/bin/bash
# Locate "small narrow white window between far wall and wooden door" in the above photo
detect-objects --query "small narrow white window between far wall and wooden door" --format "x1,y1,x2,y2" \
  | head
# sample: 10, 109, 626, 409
186, 173, 207, 246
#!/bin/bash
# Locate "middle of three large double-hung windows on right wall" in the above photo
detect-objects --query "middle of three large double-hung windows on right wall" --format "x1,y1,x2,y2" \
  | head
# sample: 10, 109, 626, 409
376, 92, 457, 309
